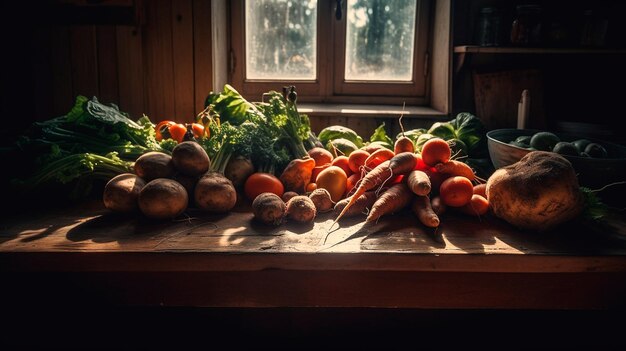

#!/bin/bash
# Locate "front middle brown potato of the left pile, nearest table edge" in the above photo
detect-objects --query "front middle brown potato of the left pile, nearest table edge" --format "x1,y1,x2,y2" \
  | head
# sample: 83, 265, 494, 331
139, 178, 189, 219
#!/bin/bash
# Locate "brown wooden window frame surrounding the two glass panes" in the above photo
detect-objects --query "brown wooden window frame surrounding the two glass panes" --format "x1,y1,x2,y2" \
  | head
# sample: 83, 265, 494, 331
228, 0, 433, 106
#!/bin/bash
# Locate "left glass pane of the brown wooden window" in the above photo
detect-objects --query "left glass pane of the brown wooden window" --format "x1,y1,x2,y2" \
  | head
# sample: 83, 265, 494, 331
245, 0, 317, 79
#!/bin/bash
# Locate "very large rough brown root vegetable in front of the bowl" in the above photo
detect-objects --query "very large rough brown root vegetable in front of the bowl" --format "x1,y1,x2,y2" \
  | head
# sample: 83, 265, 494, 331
486, 151, 584, 231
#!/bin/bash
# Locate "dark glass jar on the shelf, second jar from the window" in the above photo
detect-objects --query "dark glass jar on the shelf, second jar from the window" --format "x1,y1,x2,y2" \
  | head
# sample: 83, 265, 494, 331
511, 5, 541, 46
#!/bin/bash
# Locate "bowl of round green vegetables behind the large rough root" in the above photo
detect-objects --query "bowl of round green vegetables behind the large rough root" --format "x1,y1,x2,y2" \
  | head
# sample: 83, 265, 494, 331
487, 129, 626, 188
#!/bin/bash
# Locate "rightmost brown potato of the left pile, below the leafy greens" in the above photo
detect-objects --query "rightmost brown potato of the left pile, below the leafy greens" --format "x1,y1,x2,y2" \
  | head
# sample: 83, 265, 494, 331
194, 172, 237, 213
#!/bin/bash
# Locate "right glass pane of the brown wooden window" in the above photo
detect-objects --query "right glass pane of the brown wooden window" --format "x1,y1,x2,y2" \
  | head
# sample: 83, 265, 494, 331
345, 0, 417, 81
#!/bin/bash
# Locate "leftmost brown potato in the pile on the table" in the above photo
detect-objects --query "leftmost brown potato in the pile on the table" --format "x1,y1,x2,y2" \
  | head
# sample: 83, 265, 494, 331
102, 173, 146, 213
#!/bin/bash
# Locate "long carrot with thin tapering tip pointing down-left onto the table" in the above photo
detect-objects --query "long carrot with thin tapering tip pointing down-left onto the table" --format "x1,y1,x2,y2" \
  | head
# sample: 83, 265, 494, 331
329, 152, 415, 232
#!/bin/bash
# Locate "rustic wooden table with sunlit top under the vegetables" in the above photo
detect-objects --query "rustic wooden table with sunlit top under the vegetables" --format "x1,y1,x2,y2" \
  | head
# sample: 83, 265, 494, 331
0, 202, 626, 309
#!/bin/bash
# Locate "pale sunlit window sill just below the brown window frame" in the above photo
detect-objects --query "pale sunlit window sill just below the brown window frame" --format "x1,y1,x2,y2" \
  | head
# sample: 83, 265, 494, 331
298, 103, 448, 119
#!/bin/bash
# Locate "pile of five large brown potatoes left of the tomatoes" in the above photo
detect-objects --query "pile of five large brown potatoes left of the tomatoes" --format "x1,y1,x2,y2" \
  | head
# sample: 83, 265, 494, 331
102, 141, 237, 219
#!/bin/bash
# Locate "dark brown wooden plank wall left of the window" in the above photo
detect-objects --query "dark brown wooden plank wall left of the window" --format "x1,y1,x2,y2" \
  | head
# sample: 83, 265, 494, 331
8, 0, 213, 124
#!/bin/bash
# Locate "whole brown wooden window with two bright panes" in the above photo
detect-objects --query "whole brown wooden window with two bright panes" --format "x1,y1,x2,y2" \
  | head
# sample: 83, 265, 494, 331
229, 0, 429, 105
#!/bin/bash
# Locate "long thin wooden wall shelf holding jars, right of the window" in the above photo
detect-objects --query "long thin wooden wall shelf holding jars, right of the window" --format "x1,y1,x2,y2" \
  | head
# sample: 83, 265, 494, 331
454, 45, 626, 54
